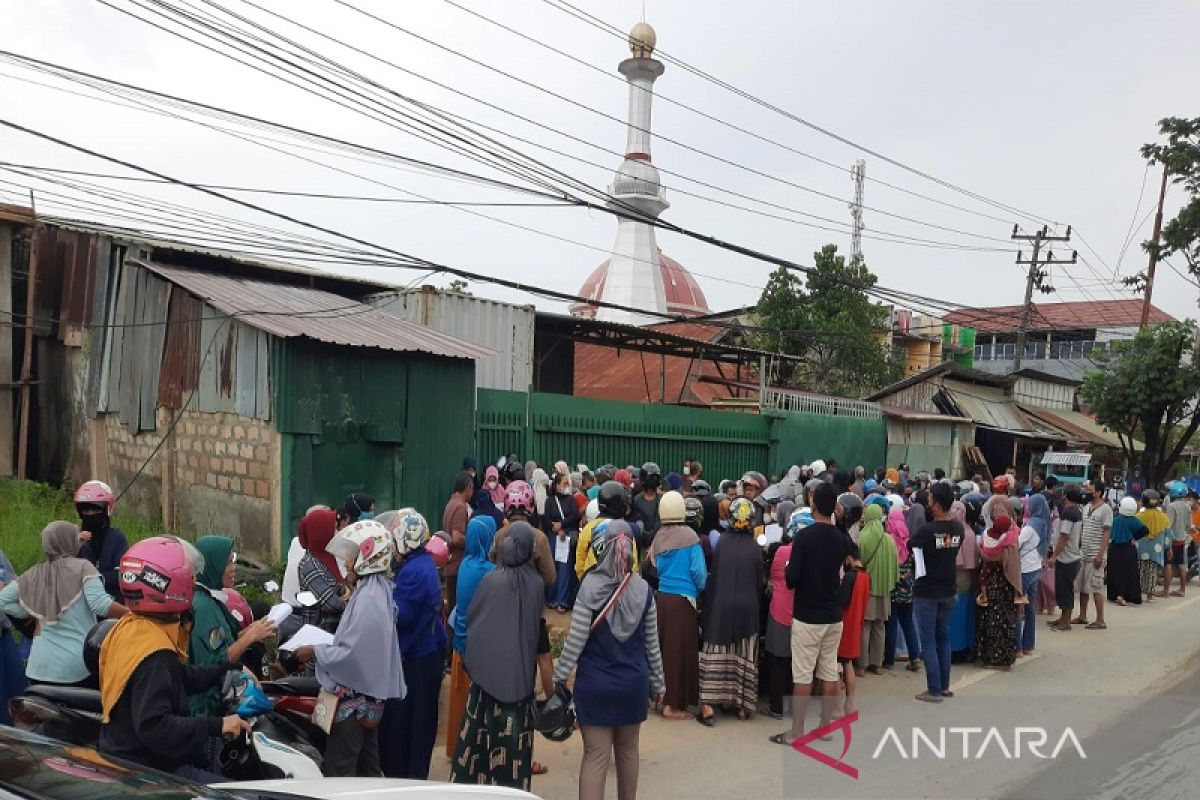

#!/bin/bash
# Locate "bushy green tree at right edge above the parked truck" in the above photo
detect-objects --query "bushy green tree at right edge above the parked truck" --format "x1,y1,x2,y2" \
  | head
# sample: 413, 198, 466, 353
1081, 320, 1200, 486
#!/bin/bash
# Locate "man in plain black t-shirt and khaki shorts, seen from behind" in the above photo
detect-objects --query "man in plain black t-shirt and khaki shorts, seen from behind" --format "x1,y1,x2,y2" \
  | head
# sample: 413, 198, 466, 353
770, 482, 853, 745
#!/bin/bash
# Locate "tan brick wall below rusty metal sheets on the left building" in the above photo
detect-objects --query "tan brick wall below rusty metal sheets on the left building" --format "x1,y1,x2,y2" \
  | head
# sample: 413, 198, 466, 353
96, 409, 278, 555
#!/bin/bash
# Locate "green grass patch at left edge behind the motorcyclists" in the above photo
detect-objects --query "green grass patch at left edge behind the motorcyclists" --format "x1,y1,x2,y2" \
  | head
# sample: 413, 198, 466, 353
0, 479, 162, 573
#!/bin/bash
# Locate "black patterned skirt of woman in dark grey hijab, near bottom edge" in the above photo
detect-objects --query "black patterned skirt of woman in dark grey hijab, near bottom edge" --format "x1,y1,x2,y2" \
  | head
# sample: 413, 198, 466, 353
450, 684, 535, 792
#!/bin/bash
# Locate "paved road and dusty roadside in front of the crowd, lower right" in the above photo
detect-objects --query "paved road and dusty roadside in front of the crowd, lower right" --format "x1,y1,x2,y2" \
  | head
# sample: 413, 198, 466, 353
431, 585, 1200, 800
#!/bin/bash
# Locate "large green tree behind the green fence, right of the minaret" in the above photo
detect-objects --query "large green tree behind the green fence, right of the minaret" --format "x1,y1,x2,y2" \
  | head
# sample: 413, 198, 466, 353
752, 245, 899, 397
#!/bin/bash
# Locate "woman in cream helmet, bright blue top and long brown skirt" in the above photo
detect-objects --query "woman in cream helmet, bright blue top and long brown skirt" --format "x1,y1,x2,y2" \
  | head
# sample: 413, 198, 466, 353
648, 491, 708, 720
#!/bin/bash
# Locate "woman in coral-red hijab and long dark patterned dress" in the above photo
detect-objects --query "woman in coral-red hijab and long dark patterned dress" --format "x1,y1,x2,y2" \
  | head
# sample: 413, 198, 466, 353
976, 515, 1028, 672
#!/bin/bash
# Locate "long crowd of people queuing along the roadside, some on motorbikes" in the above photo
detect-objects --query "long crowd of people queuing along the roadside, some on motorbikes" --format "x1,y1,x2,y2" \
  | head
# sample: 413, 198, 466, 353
0, 456, 1200, 800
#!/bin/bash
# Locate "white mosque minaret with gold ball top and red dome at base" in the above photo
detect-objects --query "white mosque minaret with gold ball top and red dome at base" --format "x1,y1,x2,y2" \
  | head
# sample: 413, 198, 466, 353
571, 22, 709, 325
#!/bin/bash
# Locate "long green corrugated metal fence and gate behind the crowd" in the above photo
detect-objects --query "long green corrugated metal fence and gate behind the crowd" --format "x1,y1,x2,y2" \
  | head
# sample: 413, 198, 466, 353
475, 390, 887, 481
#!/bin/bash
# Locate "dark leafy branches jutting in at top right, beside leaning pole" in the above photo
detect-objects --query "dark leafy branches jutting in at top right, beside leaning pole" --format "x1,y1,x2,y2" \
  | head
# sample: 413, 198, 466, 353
1126, 116, 1200, 297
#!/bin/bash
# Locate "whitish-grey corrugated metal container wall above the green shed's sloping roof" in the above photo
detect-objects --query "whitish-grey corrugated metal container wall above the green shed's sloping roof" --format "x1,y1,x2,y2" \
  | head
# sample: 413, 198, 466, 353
372, 288, 534, 391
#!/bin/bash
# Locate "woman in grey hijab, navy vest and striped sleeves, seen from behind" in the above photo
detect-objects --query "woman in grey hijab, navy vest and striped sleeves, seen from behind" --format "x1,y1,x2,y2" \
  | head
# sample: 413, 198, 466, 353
554, 522, 667, 800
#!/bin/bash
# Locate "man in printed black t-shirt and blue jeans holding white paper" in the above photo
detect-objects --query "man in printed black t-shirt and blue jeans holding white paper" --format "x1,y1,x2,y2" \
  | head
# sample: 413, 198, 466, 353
908, 483, 960, 703
